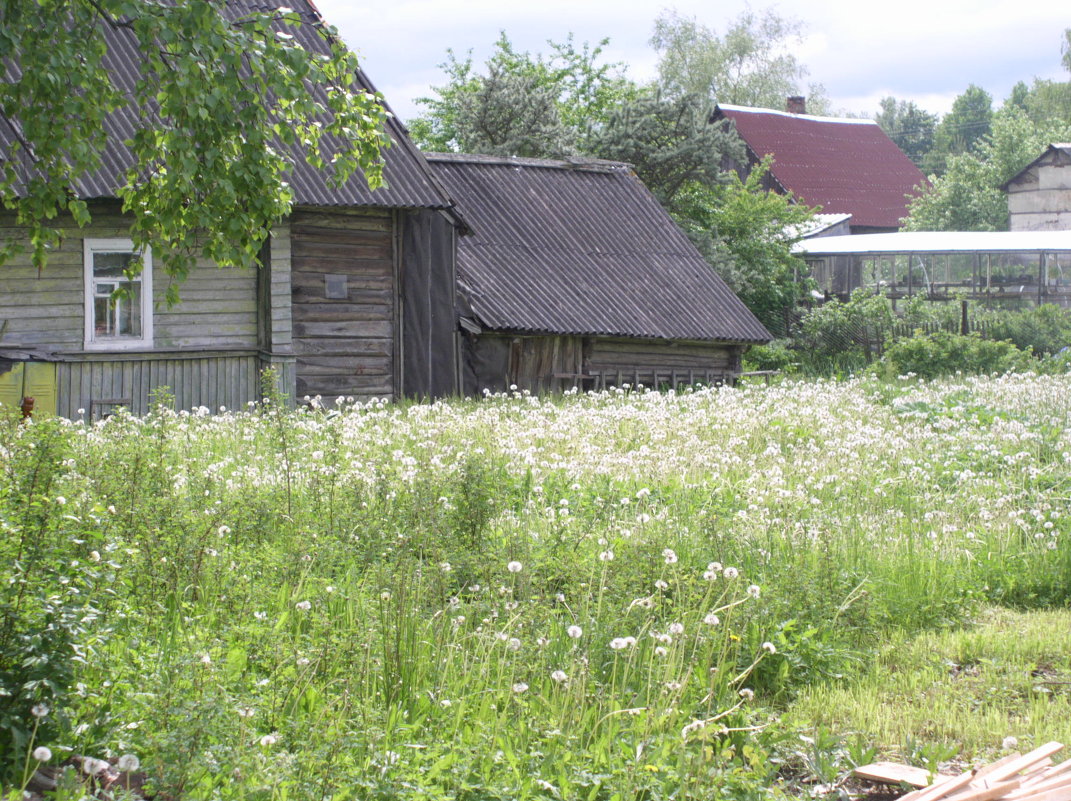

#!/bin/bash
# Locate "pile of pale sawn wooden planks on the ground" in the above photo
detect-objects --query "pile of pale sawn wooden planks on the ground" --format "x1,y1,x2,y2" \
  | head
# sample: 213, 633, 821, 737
855, 742, 1071, 801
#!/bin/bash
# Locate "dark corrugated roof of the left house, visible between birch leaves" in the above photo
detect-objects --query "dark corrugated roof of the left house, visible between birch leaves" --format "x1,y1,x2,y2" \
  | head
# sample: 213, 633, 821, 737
0, 0, 452, 209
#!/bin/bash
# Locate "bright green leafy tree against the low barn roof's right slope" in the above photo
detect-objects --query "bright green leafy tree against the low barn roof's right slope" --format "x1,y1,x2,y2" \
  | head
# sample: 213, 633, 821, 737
675, 157, 815, 335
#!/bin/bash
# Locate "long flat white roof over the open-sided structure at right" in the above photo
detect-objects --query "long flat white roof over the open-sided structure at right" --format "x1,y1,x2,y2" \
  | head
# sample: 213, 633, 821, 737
793, 231, 1071, 256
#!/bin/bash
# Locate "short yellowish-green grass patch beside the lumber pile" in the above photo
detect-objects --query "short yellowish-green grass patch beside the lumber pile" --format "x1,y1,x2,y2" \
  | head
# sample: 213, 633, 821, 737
788, 609, 1071, 760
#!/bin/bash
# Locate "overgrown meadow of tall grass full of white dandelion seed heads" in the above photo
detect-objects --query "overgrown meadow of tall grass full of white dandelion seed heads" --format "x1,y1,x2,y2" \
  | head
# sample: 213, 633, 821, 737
0, 375, 1071, 801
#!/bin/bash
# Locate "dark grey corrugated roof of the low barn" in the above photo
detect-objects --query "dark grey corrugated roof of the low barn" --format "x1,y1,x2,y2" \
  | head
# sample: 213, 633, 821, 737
426, 153, 770, 343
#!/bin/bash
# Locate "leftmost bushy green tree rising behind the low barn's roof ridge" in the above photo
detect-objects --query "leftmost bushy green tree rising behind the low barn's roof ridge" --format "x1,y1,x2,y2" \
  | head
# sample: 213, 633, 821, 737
409, 31, 636, 157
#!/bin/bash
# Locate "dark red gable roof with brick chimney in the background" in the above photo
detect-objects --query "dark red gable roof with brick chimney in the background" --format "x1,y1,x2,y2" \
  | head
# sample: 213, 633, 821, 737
714, 105, 926, 228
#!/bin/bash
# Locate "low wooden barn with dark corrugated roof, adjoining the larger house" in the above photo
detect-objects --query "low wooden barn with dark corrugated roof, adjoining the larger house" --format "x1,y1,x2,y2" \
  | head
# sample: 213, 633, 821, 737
426, 154, 770, 394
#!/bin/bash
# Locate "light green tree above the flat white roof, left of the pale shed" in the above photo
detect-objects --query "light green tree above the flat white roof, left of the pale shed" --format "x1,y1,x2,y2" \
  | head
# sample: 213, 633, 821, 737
904, 104, 1071, 231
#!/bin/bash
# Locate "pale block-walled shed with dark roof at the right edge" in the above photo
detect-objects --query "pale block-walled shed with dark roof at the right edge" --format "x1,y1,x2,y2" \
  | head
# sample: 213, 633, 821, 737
1004, 143, 1071, 231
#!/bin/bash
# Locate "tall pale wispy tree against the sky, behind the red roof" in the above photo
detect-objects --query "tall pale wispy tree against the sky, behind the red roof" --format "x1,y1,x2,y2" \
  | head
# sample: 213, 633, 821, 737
651, 10, 821, 110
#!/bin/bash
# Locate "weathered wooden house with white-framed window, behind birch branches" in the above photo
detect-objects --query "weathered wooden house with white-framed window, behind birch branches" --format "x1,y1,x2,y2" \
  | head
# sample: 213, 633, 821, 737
0, 0, 458, 418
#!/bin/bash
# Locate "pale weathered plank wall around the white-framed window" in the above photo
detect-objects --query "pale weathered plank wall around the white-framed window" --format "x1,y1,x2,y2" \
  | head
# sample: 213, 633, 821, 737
0, 205, 295, 418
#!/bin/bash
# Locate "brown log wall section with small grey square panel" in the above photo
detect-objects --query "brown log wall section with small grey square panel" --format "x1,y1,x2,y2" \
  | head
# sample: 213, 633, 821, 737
290, 211, 397, 402
